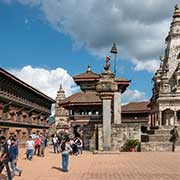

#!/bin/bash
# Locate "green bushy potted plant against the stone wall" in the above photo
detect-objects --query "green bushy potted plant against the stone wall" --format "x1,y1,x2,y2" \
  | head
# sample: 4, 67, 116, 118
123, 139, 139, 152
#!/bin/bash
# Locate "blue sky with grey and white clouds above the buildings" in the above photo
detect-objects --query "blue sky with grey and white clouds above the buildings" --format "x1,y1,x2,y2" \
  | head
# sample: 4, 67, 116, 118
0, 0, 180, 103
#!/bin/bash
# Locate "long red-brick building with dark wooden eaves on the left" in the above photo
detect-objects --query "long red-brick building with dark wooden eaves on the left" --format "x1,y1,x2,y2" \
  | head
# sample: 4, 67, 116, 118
0, 68, 55, 142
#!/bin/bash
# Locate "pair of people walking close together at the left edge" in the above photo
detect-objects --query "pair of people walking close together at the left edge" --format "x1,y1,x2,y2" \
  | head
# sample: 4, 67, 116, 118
0, 135, 22, 180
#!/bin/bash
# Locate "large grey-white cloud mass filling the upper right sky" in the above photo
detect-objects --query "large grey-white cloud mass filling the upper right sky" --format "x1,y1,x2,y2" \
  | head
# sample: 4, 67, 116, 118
17, 0, 179, 72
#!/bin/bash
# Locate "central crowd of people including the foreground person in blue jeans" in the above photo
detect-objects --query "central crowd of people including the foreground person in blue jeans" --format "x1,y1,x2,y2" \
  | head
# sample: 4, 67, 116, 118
52, 135, 83, 172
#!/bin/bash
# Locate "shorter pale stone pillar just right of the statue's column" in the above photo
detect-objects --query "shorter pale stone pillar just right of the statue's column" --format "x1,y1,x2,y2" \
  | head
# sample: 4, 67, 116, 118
114, 92, 121, 124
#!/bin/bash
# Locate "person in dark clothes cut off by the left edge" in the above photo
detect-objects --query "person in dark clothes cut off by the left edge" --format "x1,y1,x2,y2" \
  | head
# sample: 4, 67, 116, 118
0, 136, 12, 180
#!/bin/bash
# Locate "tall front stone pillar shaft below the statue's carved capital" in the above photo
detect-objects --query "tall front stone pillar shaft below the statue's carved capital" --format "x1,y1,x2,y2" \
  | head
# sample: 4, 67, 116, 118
102, 96, 111, 151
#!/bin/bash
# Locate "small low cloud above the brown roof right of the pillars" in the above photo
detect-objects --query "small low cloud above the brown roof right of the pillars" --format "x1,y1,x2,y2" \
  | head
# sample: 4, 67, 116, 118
122, 89, 147, 104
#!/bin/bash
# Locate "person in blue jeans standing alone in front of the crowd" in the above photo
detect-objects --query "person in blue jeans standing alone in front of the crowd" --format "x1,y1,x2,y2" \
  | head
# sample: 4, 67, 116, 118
61, 139, 72, 172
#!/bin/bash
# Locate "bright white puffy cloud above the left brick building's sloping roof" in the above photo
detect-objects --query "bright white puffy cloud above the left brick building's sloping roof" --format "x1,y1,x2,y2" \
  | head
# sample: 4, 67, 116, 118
9, 65, 77, 99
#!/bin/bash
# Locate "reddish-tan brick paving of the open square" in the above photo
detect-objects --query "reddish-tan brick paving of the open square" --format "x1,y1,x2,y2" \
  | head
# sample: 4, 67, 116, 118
1, 149, 180, 180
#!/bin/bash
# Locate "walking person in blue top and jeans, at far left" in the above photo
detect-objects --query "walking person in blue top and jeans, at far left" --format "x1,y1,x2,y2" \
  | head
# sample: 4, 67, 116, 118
9, 138, 22, 176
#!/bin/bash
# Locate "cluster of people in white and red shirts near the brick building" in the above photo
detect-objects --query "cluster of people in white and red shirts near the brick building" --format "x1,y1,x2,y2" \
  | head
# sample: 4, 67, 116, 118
26, 134, 48, 160
